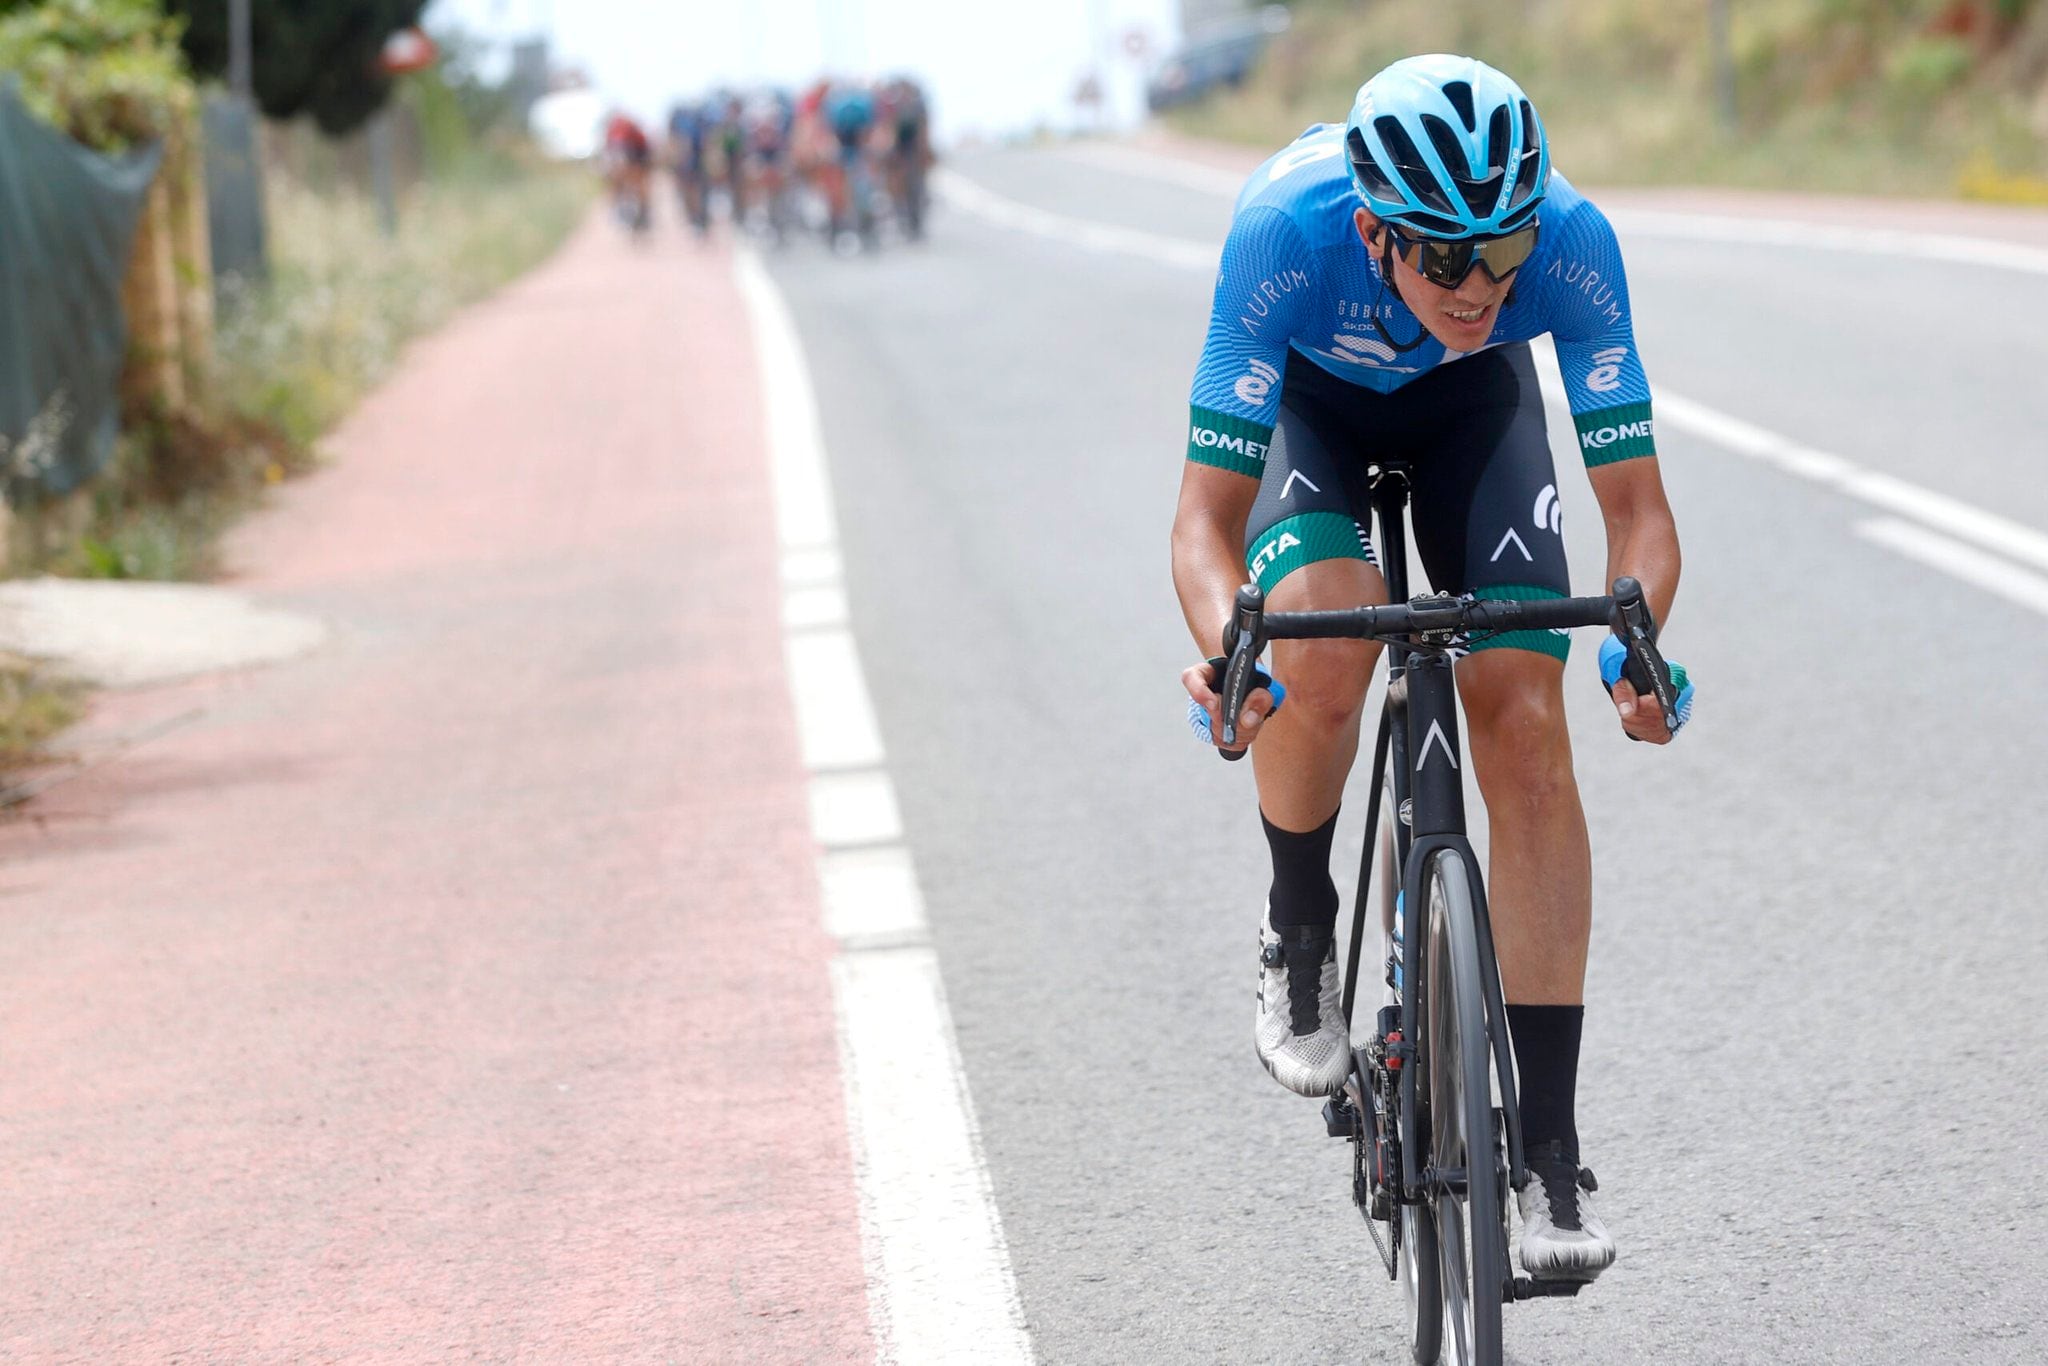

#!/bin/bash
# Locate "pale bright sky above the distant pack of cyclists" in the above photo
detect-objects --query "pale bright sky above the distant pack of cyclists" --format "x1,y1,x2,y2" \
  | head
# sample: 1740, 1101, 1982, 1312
428, 0, 1180, 137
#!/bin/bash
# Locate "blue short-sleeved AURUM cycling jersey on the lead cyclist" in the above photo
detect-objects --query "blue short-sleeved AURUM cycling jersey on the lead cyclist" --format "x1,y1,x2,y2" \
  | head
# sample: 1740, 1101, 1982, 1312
1188, 123, 1657, 477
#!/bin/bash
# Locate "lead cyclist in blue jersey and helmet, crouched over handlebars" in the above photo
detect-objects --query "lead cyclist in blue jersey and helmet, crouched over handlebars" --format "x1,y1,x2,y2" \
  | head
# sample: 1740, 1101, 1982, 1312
1174, 55, 1679, 1280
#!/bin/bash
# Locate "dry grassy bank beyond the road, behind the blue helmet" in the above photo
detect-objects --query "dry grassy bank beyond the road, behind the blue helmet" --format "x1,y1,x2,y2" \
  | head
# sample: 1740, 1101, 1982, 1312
1171, 0, 2048, 203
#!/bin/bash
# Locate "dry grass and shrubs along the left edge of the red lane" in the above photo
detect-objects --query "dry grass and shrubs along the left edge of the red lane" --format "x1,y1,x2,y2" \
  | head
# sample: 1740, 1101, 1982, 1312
0, 0, 594, 770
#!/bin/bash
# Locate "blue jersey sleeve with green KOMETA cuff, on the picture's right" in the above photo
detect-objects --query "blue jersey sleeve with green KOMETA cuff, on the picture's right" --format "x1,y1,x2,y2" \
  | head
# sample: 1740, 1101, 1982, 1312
1542, 201, 1657, 469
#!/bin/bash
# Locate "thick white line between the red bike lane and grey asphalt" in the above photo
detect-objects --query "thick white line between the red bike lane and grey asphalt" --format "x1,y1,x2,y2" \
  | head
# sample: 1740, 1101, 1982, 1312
735, 252, 1032, 1366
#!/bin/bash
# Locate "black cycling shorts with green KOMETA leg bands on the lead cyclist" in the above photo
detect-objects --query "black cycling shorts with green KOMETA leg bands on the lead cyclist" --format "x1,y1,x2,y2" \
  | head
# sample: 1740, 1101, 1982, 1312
1245, 342, 1571, 659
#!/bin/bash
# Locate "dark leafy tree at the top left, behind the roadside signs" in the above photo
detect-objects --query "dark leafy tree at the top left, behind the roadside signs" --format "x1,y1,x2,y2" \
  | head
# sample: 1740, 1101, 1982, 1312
164, 0, 428, 137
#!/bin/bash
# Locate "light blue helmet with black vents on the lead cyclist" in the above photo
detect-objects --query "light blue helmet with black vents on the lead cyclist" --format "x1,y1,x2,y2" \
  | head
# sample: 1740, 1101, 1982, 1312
1343, 53, 1550, 242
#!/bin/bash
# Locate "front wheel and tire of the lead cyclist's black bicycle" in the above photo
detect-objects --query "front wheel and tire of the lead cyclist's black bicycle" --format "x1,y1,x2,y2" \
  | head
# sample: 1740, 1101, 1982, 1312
1411, 850, 1507, 1366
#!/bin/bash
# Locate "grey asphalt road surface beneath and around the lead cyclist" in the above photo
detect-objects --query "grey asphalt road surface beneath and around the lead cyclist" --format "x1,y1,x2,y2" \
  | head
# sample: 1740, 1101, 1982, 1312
774, 152, 2048, 1366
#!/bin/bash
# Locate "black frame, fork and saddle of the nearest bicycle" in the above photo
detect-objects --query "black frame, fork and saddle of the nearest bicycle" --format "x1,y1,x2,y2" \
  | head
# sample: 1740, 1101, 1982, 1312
1343, 467, 1528, 1204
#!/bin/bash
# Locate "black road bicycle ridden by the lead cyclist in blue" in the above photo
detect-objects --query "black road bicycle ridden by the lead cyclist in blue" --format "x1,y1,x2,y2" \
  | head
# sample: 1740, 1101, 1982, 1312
1221, 463, 1677, 1366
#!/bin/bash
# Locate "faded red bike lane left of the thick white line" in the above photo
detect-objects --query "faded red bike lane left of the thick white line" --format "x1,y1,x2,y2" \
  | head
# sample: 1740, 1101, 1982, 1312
0, 221, 874, 1362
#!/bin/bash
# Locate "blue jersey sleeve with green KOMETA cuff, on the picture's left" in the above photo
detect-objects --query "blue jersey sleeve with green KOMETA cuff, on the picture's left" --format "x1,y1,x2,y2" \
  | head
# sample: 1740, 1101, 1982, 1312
1188, 205, 1315, 479
